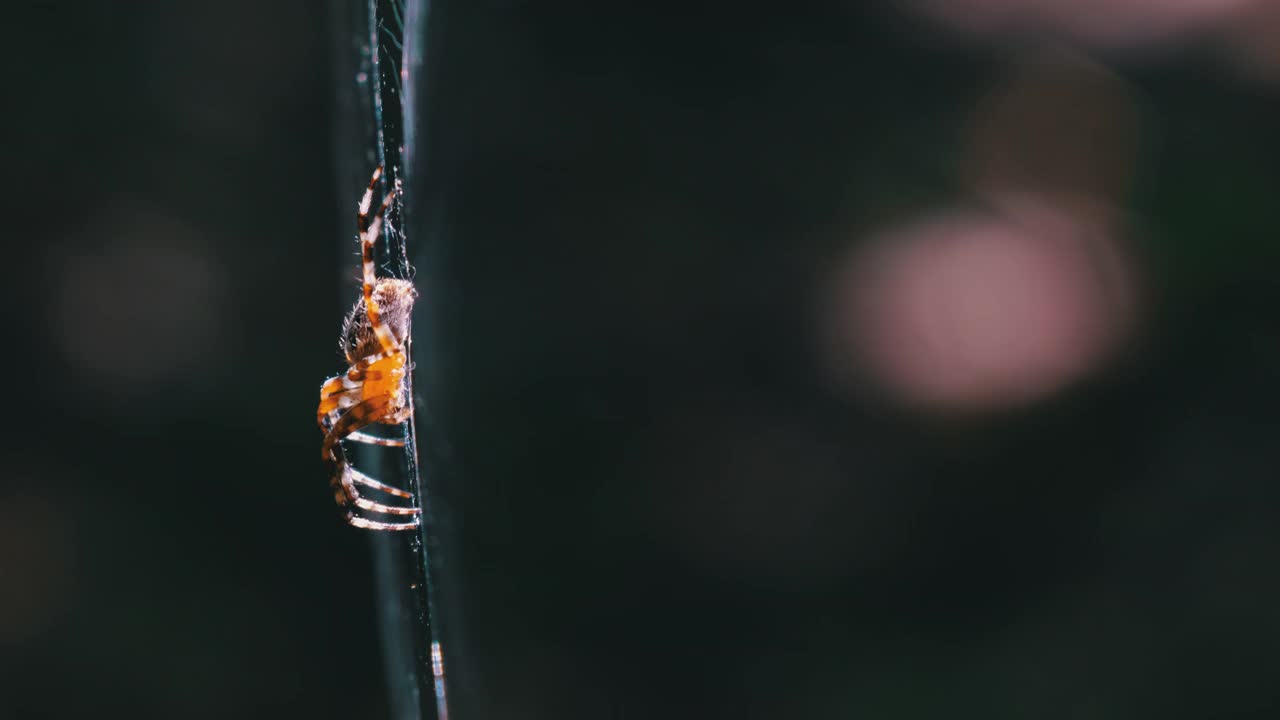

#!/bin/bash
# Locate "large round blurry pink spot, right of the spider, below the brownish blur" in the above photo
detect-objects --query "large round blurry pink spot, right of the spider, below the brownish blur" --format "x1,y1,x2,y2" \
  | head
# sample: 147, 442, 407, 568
831, 202, 1123, 409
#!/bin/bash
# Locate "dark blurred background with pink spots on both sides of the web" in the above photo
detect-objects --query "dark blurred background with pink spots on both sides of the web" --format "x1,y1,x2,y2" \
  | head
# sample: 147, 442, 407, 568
0, 0, 1280, 720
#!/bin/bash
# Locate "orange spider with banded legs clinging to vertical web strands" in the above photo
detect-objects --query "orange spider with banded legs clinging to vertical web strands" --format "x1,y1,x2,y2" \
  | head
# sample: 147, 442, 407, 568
316, 167, 421, 530
